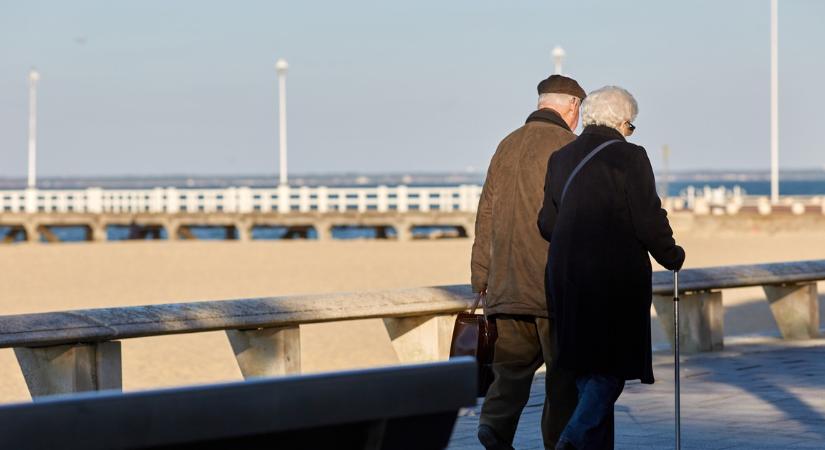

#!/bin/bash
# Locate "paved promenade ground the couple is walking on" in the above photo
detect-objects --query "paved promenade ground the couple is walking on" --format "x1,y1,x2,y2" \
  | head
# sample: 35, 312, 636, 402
449, 338, 825, 450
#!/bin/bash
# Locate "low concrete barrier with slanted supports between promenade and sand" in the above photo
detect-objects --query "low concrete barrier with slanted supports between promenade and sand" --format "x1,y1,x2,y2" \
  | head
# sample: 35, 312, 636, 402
0, 260, 825, 397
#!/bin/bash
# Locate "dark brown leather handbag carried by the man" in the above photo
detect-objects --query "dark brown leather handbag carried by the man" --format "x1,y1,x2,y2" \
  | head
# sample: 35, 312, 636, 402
450, 294, 498, 397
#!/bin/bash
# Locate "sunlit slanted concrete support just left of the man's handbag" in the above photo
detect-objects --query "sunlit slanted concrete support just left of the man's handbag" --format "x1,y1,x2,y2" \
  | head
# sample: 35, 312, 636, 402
384, 315, 456, 363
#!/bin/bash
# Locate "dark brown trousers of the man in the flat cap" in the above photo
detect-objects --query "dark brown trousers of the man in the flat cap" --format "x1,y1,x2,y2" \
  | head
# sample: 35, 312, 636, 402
479, 315, 578, 449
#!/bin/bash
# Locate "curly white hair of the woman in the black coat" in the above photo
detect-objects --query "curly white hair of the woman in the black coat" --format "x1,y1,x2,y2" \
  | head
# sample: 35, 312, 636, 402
582, 86, 639, 129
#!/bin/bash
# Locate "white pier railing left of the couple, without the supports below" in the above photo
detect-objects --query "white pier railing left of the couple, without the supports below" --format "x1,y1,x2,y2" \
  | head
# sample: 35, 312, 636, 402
0, 185, 481, 214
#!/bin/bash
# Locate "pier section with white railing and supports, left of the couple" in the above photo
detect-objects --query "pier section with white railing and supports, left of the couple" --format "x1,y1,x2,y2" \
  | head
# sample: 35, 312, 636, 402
0, 185, 481, 242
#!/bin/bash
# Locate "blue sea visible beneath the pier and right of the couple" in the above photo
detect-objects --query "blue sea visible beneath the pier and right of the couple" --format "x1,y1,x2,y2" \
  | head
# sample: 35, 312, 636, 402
6, 179, 825, 242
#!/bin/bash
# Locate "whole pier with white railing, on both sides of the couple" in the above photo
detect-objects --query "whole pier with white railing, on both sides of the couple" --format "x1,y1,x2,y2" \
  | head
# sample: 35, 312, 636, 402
0, 184, 825, 242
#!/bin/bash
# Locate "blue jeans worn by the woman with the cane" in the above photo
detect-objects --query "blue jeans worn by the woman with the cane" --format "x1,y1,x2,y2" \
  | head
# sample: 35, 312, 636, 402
559, 374, 624, 450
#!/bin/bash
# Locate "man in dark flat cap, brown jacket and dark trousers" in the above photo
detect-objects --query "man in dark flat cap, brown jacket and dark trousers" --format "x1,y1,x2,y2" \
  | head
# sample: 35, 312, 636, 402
471, 75, 585, 449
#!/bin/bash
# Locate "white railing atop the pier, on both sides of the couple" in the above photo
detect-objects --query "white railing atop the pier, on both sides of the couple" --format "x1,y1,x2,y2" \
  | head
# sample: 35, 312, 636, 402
0, 185, 825, 215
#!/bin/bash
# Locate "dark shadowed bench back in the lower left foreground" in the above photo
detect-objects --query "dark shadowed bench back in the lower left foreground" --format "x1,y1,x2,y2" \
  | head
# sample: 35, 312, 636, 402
0, 358, 477, 450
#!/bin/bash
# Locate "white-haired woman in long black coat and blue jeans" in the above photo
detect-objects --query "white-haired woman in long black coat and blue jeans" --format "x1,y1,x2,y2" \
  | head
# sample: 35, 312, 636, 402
539, 86, 685, 450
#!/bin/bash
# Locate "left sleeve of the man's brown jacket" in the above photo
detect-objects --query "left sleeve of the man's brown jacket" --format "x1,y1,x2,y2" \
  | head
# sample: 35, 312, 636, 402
470, 158, 495, 292
